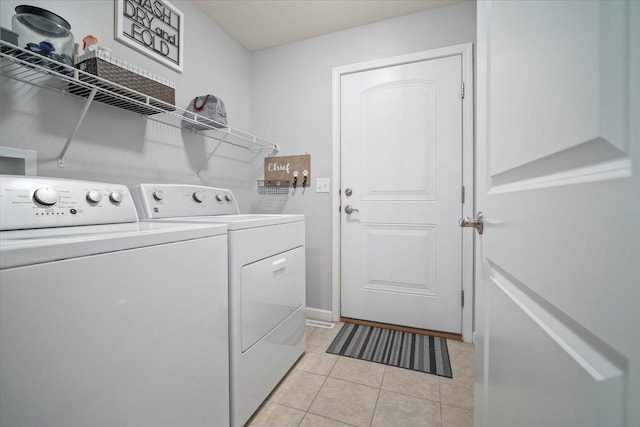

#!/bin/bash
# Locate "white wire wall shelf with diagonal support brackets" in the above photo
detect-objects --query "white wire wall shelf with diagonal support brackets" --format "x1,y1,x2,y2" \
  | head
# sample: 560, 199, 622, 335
0, 41, 279, 169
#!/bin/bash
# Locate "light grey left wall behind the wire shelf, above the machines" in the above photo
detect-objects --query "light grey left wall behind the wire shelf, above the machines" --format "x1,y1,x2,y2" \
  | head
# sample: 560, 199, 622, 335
0, 0, 255, 210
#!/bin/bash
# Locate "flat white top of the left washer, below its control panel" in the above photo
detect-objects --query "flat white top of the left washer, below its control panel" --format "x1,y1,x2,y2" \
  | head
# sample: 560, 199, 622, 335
0, 222, 227, 269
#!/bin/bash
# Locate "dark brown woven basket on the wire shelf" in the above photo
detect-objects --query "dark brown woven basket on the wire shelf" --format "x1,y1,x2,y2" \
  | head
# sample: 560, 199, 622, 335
70, 58, 175, 115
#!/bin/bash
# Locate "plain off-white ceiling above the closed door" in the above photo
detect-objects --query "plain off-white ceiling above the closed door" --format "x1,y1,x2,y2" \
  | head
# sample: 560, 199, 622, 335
192, 0, 469, 51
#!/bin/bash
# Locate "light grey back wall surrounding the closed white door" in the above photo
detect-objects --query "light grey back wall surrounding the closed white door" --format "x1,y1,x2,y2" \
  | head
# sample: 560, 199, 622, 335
251, 2, 476, 310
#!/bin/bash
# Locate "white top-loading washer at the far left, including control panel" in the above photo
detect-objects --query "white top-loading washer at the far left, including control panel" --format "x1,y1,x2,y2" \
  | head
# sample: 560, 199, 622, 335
0, 176, 229, 427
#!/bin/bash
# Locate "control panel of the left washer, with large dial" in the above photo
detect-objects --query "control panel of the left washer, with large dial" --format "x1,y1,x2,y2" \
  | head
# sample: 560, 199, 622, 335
0, 175, 138, 230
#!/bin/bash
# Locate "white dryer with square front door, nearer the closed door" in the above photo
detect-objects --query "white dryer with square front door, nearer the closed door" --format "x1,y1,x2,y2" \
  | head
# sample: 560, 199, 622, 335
132, 184, 305, 426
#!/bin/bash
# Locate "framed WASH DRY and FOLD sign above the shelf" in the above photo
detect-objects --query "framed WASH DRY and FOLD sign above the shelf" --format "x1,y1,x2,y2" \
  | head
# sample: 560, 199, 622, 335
115, 0, 184, 72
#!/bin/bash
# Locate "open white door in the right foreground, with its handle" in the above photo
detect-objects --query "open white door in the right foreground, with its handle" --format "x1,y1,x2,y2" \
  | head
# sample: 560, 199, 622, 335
472, 1, 640, 427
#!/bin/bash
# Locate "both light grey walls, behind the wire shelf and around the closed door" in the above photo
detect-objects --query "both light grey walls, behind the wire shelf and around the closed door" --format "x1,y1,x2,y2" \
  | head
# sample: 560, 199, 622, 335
0, 0, 476, 310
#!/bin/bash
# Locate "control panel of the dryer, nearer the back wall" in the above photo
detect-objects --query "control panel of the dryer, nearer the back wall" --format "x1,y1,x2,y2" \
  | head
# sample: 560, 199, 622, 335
131, 184, 240, 219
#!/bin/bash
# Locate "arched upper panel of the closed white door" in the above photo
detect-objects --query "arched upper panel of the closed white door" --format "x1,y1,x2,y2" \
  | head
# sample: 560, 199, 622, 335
359, 80, 437, 201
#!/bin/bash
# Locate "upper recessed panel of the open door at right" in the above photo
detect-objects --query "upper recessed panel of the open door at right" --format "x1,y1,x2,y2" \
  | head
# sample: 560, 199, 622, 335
488, 1, 628, 175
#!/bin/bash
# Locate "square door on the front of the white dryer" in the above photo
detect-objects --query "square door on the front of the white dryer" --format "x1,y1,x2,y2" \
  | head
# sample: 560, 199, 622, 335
240, 247, 305, 353
